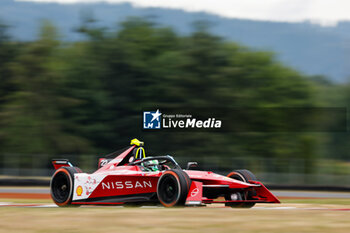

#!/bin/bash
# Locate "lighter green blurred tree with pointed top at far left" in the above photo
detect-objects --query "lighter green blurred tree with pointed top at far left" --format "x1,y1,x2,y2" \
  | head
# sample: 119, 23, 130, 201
3, 21, 88, 154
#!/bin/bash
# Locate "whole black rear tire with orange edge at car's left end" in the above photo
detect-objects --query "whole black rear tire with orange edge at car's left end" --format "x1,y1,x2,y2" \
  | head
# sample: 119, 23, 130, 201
50, 167, 82, 207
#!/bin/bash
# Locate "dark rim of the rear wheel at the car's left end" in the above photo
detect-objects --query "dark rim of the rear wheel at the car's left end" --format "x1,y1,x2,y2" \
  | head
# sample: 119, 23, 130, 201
51, 172, 70, 203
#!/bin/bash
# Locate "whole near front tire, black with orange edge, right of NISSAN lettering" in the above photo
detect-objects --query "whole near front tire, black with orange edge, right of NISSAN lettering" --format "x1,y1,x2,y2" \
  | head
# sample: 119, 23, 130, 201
157, 169, 191, 207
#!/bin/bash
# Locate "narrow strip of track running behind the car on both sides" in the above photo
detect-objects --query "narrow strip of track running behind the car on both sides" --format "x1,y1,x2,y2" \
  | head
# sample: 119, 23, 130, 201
0, 187, 350, 199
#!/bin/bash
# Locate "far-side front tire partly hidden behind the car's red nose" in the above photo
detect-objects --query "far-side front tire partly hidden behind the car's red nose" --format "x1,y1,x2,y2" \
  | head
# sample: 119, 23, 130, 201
225, 169, 257, 208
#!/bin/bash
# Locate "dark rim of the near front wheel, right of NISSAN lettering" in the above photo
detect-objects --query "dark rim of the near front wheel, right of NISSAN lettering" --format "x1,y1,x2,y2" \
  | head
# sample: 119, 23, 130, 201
159, 175, 179, 204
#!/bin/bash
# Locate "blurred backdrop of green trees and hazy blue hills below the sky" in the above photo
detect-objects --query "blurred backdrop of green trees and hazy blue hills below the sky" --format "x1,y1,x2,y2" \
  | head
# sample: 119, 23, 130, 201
0, 0, 350, 187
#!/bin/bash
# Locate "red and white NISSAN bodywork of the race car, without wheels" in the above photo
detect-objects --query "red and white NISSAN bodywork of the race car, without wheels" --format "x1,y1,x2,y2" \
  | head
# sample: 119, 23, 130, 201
58, 146, 280, 205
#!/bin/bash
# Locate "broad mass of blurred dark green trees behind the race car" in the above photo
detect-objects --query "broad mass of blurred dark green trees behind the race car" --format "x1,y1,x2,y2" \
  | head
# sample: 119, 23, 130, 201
0, 14, 349, 172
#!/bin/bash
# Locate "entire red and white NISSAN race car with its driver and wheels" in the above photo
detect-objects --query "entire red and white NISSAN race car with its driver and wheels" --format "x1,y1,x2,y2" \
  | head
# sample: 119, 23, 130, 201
50, 139, 280, 208
